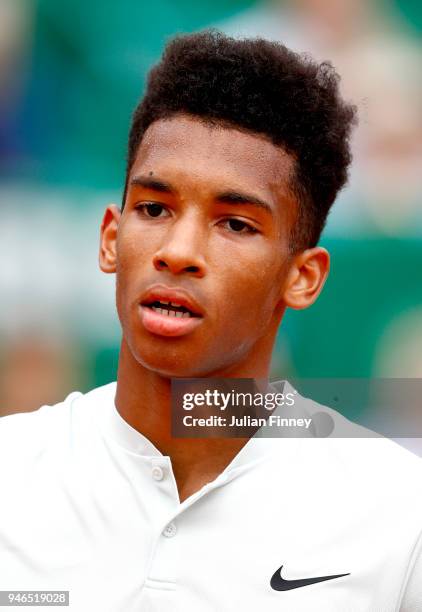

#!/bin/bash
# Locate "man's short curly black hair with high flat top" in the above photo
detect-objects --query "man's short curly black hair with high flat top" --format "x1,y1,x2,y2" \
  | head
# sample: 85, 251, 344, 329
122, 30, 356, 251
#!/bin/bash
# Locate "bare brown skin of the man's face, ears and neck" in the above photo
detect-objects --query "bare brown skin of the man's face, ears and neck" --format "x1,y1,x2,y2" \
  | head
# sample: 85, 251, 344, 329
99, 115, 329, 501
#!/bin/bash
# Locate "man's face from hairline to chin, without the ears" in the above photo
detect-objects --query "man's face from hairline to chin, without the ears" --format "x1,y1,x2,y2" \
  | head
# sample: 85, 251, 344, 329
109, 115, 296, 377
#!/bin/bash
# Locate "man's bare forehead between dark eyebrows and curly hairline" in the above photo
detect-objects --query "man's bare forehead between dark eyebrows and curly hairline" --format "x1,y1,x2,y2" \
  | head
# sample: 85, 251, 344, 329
131, 115, 294, 195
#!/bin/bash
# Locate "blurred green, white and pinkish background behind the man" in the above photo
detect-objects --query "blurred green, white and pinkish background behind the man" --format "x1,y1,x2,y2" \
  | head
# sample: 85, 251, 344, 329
0, 0, 422, 414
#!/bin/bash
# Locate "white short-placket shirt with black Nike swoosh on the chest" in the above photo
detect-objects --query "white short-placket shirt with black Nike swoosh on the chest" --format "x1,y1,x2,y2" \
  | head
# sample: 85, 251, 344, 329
0, 383, 422, 612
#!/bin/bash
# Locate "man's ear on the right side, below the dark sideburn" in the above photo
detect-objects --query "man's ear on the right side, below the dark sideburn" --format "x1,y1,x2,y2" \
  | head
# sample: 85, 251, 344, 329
283, 247, 330, 310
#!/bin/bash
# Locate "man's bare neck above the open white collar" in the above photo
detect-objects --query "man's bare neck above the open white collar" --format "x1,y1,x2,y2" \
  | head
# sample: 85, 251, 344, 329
115, 339, 271, 501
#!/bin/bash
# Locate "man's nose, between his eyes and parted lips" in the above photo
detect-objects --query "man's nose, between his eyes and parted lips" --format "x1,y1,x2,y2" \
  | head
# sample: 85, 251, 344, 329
153, 212, 206, 277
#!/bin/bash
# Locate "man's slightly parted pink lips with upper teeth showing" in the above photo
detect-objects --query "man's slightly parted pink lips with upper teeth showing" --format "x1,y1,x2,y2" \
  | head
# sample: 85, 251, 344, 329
140, 285, 204, 336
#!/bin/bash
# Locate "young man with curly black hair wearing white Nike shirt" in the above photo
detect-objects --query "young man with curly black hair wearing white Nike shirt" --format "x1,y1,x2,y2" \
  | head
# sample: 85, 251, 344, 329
0, 32, 422, 612
